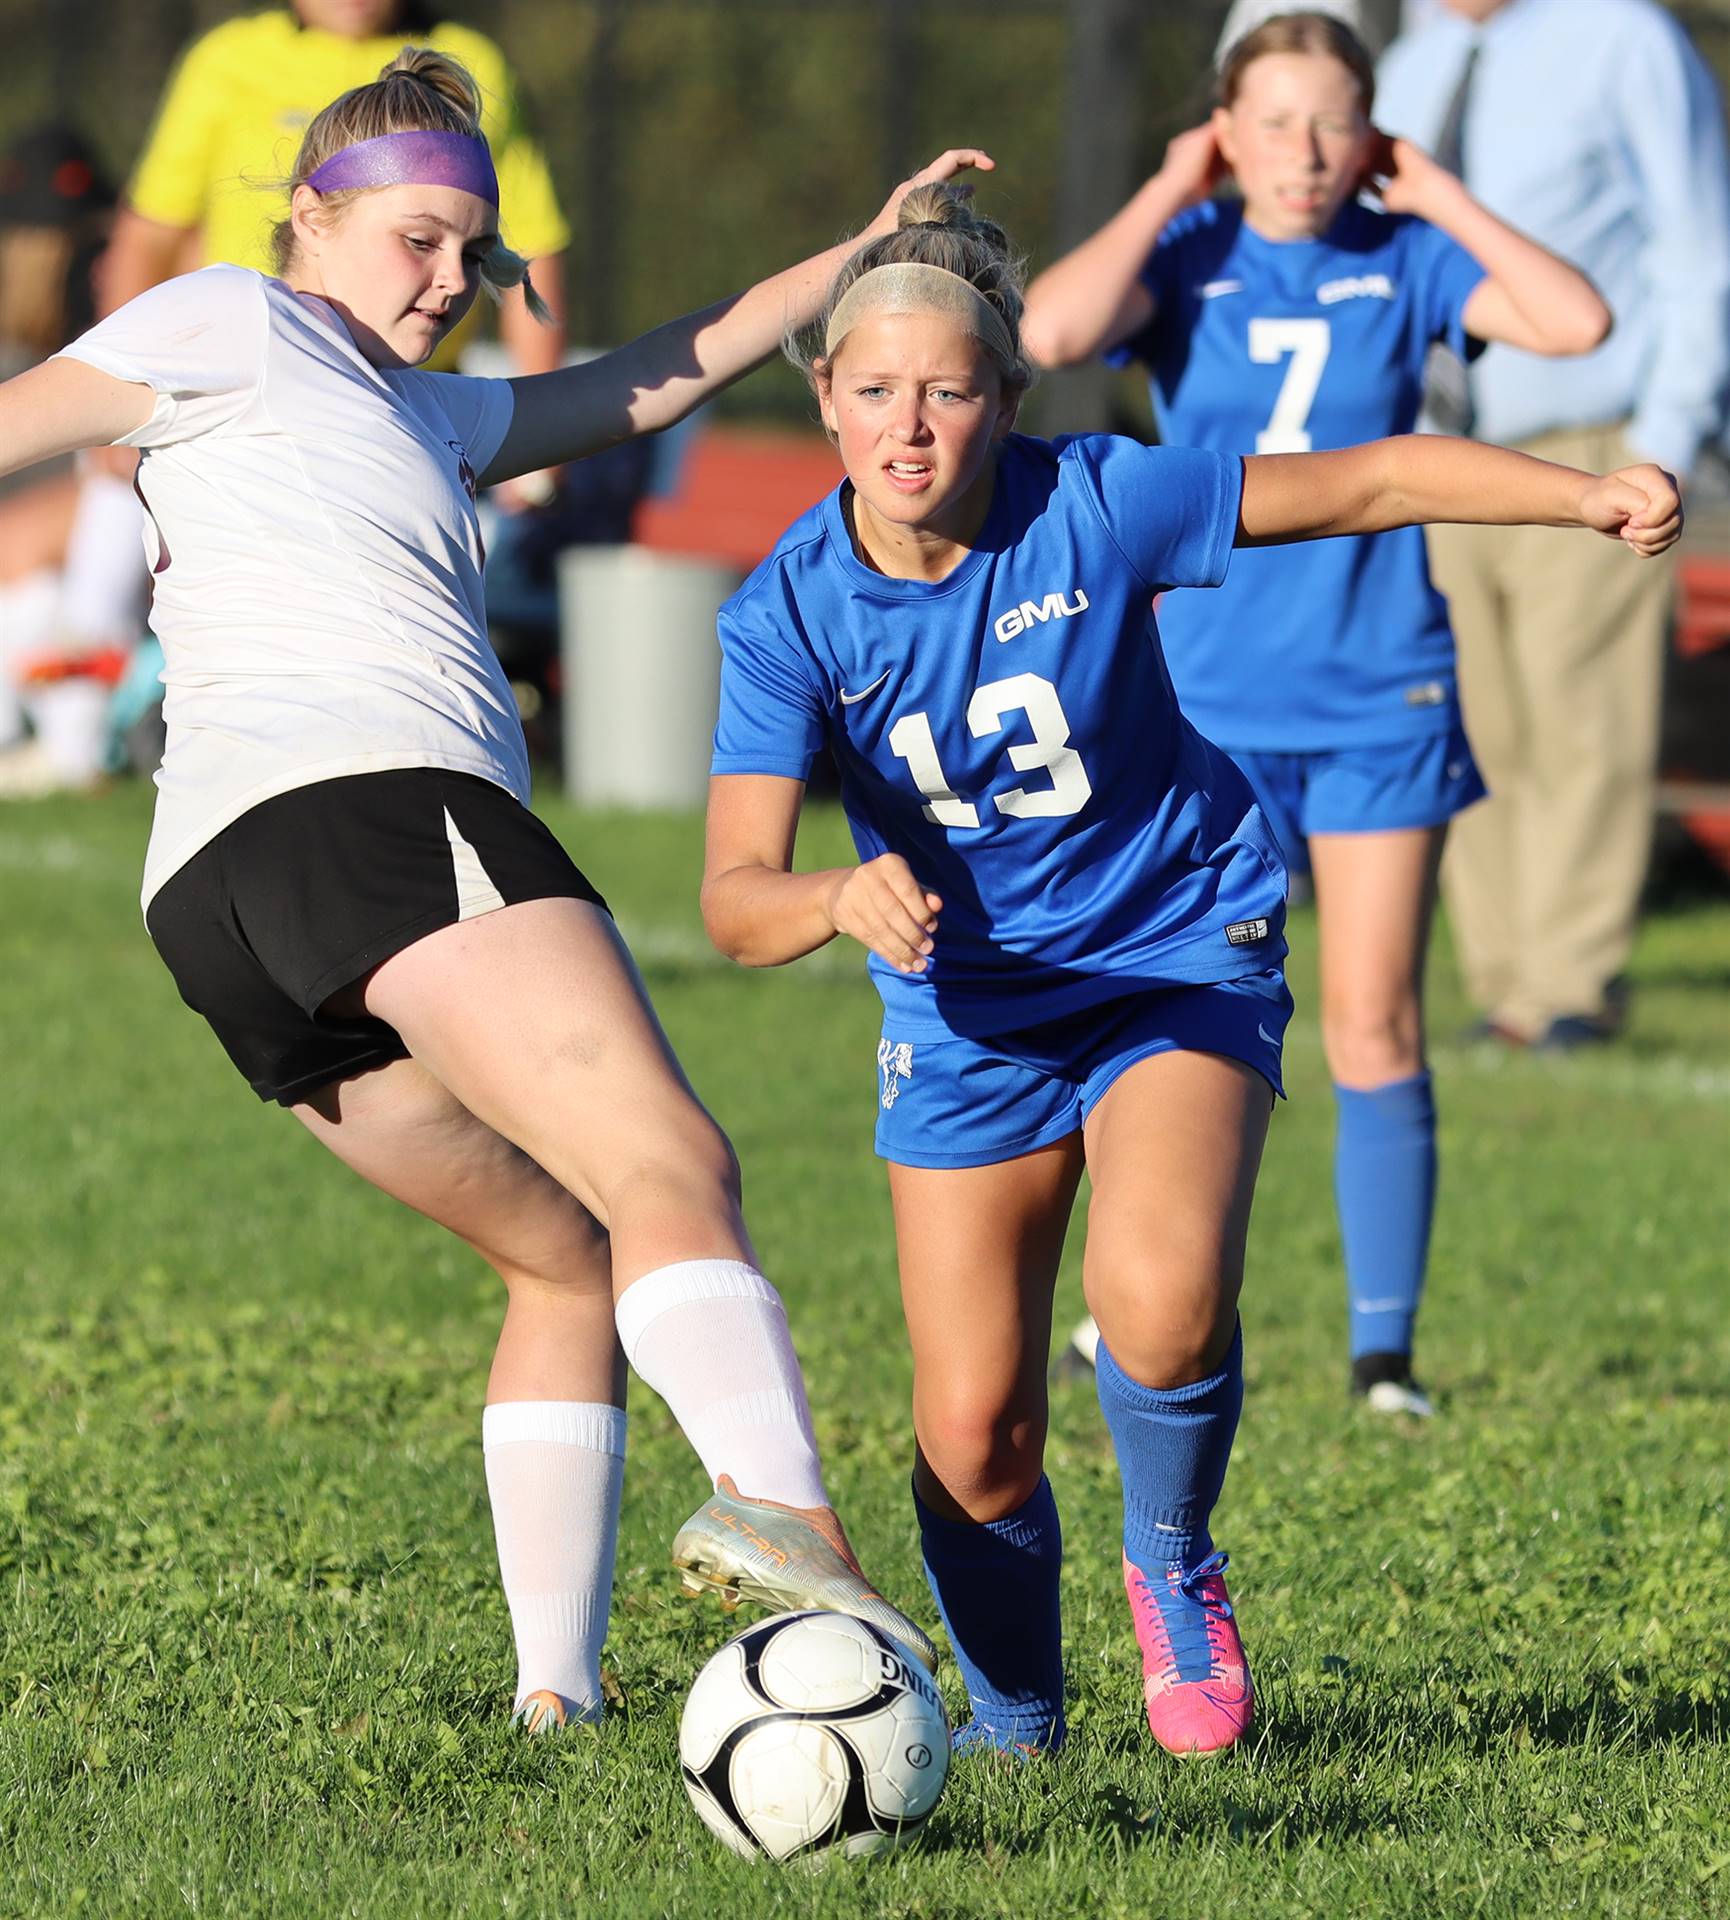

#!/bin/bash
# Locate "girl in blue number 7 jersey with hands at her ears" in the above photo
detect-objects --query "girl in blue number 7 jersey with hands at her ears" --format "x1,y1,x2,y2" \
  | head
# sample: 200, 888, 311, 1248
1027, 13, 1609, 1415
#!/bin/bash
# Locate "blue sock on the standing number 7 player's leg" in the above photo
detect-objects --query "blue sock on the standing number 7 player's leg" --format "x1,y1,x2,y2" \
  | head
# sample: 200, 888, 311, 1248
1334, 1071, 1436, 1359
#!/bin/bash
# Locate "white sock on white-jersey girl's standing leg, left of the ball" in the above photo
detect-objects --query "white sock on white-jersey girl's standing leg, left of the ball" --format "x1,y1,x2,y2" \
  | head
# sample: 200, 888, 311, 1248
480, 1400, 624, 1718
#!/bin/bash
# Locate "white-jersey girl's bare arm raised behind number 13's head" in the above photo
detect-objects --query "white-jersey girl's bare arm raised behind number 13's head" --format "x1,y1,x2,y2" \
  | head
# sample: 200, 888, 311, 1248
482, 146, 997, 486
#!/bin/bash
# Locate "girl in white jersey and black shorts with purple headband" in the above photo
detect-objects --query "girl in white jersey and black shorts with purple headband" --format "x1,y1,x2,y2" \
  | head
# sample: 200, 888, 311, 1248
0, 50, 991, 1730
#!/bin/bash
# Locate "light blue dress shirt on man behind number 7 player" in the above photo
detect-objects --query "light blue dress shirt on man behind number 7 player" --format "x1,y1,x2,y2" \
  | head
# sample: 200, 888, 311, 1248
1377, 0, 1730, 472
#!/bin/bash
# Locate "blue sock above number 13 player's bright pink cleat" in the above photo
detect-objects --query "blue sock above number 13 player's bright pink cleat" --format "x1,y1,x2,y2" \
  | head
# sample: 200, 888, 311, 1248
1094, 1327, 1244, 1572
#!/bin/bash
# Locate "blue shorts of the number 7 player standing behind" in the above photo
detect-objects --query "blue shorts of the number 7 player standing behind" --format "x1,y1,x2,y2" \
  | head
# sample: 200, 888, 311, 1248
1227, 724, 1488, 874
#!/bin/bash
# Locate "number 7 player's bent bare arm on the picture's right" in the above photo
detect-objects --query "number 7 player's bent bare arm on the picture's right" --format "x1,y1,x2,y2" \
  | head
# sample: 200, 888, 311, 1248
1369, 138, 1611, 353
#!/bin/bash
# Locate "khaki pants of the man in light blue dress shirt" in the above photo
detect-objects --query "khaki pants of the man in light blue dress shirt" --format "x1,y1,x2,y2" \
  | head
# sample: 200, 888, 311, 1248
1430, 424, 1670, 1039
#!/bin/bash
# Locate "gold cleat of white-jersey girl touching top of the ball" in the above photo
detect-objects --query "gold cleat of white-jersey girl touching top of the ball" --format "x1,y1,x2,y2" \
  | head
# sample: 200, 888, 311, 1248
672, 1475, 937, 1672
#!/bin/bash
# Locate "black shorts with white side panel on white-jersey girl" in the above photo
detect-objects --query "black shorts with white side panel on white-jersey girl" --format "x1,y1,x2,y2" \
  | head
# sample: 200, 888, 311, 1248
144, 766, 607, 1106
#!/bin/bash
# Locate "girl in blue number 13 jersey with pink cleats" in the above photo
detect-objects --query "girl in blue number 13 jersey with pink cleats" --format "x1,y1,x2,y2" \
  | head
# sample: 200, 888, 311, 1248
703, 188, 1678, 1751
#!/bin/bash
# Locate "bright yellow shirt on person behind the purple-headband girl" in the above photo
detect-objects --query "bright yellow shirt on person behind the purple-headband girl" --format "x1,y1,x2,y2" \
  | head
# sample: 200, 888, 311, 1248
127, 12, 570, 273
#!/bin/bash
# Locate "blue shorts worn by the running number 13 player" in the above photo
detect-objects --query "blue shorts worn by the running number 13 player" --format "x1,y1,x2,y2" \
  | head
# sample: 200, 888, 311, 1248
877, 968, 1292, 1167
